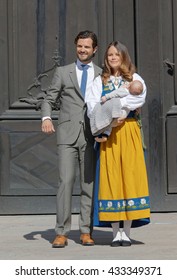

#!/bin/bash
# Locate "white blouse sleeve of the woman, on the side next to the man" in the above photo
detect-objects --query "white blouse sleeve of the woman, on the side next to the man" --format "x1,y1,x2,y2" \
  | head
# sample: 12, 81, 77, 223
85, 76, 102, 118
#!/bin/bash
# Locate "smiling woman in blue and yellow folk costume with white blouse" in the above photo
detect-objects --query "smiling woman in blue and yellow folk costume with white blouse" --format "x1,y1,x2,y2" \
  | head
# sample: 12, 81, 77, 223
87, 42, 150, 247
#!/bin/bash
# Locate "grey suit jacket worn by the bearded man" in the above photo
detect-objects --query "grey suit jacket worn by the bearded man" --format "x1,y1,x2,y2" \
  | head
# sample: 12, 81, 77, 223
41, 63, 102, 144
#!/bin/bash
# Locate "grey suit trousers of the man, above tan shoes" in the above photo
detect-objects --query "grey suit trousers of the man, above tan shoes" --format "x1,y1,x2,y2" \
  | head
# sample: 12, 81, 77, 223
55, 127, 95, 236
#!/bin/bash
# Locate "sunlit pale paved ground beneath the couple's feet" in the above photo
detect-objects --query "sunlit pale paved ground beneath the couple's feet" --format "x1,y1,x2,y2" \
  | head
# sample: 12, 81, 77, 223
0, 213, 177, 260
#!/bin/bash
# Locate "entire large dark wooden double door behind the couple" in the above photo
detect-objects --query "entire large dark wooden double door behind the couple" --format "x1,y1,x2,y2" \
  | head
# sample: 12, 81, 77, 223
0, 0, 177, 214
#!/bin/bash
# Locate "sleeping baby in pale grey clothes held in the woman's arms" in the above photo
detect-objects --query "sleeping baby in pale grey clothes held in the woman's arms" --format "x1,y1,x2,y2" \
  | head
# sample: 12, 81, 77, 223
90, 80, 143, 141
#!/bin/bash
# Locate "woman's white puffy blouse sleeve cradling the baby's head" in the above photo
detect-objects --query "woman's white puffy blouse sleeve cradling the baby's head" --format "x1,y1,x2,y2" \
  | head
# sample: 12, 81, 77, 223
120, 73, 147, 111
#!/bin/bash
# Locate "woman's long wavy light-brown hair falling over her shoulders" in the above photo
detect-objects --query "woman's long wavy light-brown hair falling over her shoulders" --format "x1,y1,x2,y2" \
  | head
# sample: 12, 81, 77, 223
102, 41, 135, 84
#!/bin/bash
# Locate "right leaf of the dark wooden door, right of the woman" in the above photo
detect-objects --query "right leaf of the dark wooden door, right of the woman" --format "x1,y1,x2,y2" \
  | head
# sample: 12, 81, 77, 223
136, 0, 177, 211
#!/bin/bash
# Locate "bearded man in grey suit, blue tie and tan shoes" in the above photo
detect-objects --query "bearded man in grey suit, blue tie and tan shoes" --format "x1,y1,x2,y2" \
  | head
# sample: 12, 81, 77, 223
41, 30, 102, 248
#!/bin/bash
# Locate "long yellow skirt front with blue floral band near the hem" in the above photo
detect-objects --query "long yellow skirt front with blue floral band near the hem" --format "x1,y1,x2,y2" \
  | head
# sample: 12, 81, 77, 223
98, 119, 150, 221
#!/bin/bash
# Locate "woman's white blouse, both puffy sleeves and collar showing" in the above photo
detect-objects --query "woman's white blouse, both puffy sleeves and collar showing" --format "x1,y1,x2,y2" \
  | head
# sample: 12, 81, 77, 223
85, 73, 147, 117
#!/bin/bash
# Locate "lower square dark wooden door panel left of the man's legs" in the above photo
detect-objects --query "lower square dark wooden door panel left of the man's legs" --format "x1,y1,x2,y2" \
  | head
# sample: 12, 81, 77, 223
0, 120, 80, 196
